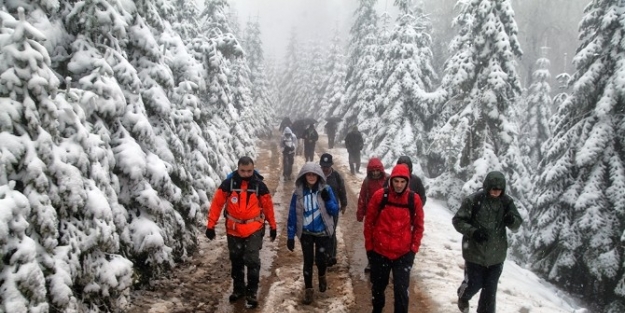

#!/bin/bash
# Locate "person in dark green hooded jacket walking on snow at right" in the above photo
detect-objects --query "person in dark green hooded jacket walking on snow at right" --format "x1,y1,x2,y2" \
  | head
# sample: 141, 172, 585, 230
452, 171, 523, 313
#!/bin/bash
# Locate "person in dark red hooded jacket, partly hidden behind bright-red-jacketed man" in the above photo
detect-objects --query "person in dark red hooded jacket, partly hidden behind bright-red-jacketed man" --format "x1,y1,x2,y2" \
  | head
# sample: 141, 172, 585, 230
356, 158, 388, 273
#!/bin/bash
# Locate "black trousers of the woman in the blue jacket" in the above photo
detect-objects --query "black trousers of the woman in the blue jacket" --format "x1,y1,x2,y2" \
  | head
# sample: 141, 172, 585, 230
300, 233, 330, 288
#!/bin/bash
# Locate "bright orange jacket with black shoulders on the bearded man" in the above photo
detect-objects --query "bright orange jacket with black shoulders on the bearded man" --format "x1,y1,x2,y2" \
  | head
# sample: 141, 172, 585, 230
206, 172, 276, 238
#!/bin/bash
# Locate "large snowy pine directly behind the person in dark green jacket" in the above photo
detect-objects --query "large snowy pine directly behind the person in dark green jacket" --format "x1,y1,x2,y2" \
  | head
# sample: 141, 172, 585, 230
430, 0, 529, 208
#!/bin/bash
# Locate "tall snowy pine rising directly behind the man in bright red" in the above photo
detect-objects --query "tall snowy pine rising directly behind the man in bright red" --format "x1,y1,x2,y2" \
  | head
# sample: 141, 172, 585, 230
369, 0, 436, 176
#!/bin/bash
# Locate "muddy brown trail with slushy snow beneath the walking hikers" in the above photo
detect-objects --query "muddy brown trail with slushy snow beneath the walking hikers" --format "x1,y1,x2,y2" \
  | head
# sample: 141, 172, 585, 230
126, 133, 438, 313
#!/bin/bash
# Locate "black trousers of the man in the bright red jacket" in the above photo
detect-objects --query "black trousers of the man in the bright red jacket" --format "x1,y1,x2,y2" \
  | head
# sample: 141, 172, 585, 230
369, 252, 415, 313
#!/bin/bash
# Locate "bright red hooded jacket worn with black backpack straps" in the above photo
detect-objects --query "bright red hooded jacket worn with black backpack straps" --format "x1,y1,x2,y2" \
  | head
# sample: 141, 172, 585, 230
364, 164, 424, 260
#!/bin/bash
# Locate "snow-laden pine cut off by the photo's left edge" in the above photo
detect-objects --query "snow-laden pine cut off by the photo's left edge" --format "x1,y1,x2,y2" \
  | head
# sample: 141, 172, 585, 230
0, 7, 51, 312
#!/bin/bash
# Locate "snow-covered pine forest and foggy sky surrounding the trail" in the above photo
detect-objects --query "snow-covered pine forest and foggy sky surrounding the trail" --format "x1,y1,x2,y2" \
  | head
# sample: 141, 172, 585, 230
0, 0, 625, 313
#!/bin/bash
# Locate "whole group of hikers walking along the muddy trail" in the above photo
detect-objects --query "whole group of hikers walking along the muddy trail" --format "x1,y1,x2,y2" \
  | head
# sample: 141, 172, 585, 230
206, 118, 522, 313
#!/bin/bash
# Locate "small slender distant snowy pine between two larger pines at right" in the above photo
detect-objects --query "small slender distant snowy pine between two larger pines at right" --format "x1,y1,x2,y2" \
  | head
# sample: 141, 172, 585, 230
520, 49, 553, 168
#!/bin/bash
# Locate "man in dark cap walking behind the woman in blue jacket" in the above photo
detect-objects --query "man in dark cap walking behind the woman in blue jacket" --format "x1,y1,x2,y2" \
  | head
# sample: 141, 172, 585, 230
319, 153, 347, 266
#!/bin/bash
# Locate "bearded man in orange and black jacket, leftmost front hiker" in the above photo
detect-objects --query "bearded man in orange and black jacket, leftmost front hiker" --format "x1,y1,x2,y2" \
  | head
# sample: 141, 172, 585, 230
206, 157, 277, 308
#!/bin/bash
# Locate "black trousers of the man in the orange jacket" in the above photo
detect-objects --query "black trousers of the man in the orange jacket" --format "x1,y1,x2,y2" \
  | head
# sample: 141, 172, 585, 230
227, 229, 263, 295
